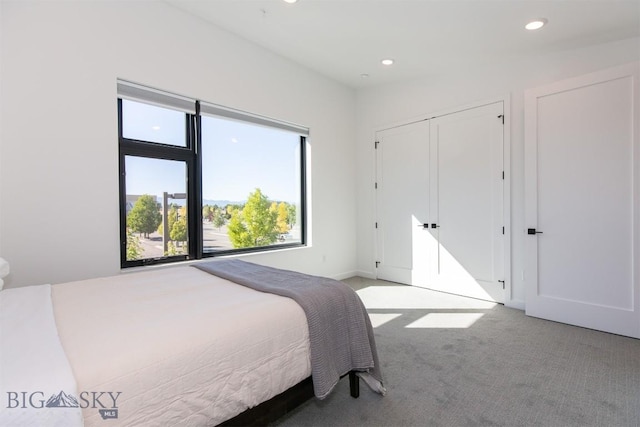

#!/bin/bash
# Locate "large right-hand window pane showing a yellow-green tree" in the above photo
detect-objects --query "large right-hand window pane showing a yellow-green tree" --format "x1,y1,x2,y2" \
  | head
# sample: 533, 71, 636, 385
202, 117, 302, 252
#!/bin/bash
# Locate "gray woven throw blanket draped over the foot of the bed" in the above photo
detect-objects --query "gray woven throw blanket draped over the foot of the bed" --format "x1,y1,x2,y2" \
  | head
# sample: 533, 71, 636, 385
194, 259, 386, 399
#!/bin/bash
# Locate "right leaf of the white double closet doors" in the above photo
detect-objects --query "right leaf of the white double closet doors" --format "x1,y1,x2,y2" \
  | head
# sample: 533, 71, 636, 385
428, 102, 505, 302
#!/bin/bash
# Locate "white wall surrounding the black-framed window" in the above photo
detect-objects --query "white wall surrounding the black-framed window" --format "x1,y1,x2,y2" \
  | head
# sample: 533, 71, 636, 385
0, 1, 356, 286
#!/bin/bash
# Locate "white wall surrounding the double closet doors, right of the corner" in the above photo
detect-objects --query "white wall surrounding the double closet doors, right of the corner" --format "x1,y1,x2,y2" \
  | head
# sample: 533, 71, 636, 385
356, 38, 640, 308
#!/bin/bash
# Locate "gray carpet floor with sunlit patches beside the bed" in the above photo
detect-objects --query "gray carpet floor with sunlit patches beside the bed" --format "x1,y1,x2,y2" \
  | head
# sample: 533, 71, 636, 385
275, 278, 640, 427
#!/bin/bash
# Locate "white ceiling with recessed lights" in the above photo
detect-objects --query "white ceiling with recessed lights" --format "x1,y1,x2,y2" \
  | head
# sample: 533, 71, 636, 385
165, 0, 640, 88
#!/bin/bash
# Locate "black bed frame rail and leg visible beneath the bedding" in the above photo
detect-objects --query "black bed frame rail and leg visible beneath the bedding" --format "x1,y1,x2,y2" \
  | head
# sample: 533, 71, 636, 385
219, 371, 360, 427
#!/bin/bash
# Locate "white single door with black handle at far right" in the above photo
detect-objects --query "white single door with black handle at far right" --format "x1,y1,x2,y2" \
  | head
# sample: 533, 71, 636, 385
525, 64, 640, 338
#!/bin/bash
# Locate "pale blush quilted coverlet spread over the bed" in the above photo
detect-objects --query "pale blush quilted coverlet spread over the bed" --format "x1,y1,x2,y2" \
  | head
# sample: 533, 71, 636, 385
52, 267, 311, 427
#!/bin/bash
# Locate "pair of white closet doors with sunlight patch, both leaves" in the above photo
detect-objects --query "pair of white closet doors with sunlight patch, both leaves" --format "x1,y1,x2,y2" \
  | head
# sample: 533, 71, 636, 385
376, 102, 505, 302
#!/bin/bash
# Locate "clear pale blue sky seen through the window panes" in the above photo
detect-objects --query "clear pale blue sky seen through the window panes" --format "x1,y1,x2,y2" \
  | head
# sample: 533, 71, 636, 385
123, 101, 300, 203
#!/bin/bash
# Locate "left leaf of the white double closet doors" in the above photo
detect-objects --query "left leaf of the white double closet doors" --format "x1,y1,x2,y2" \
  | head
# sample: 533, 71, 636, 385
376, 121, 430, 284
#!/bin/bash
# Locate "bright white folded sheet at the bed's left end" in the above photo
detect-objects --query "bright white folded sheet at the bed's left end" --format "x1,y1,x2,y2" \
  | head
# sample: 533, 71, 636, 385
0, 285, 82, 427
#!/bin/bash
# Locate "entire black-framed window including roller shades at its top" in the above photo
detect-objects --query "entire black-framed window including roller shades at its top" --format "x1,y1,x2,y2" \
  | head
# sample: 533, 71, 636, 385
118, 81, 308, 267
